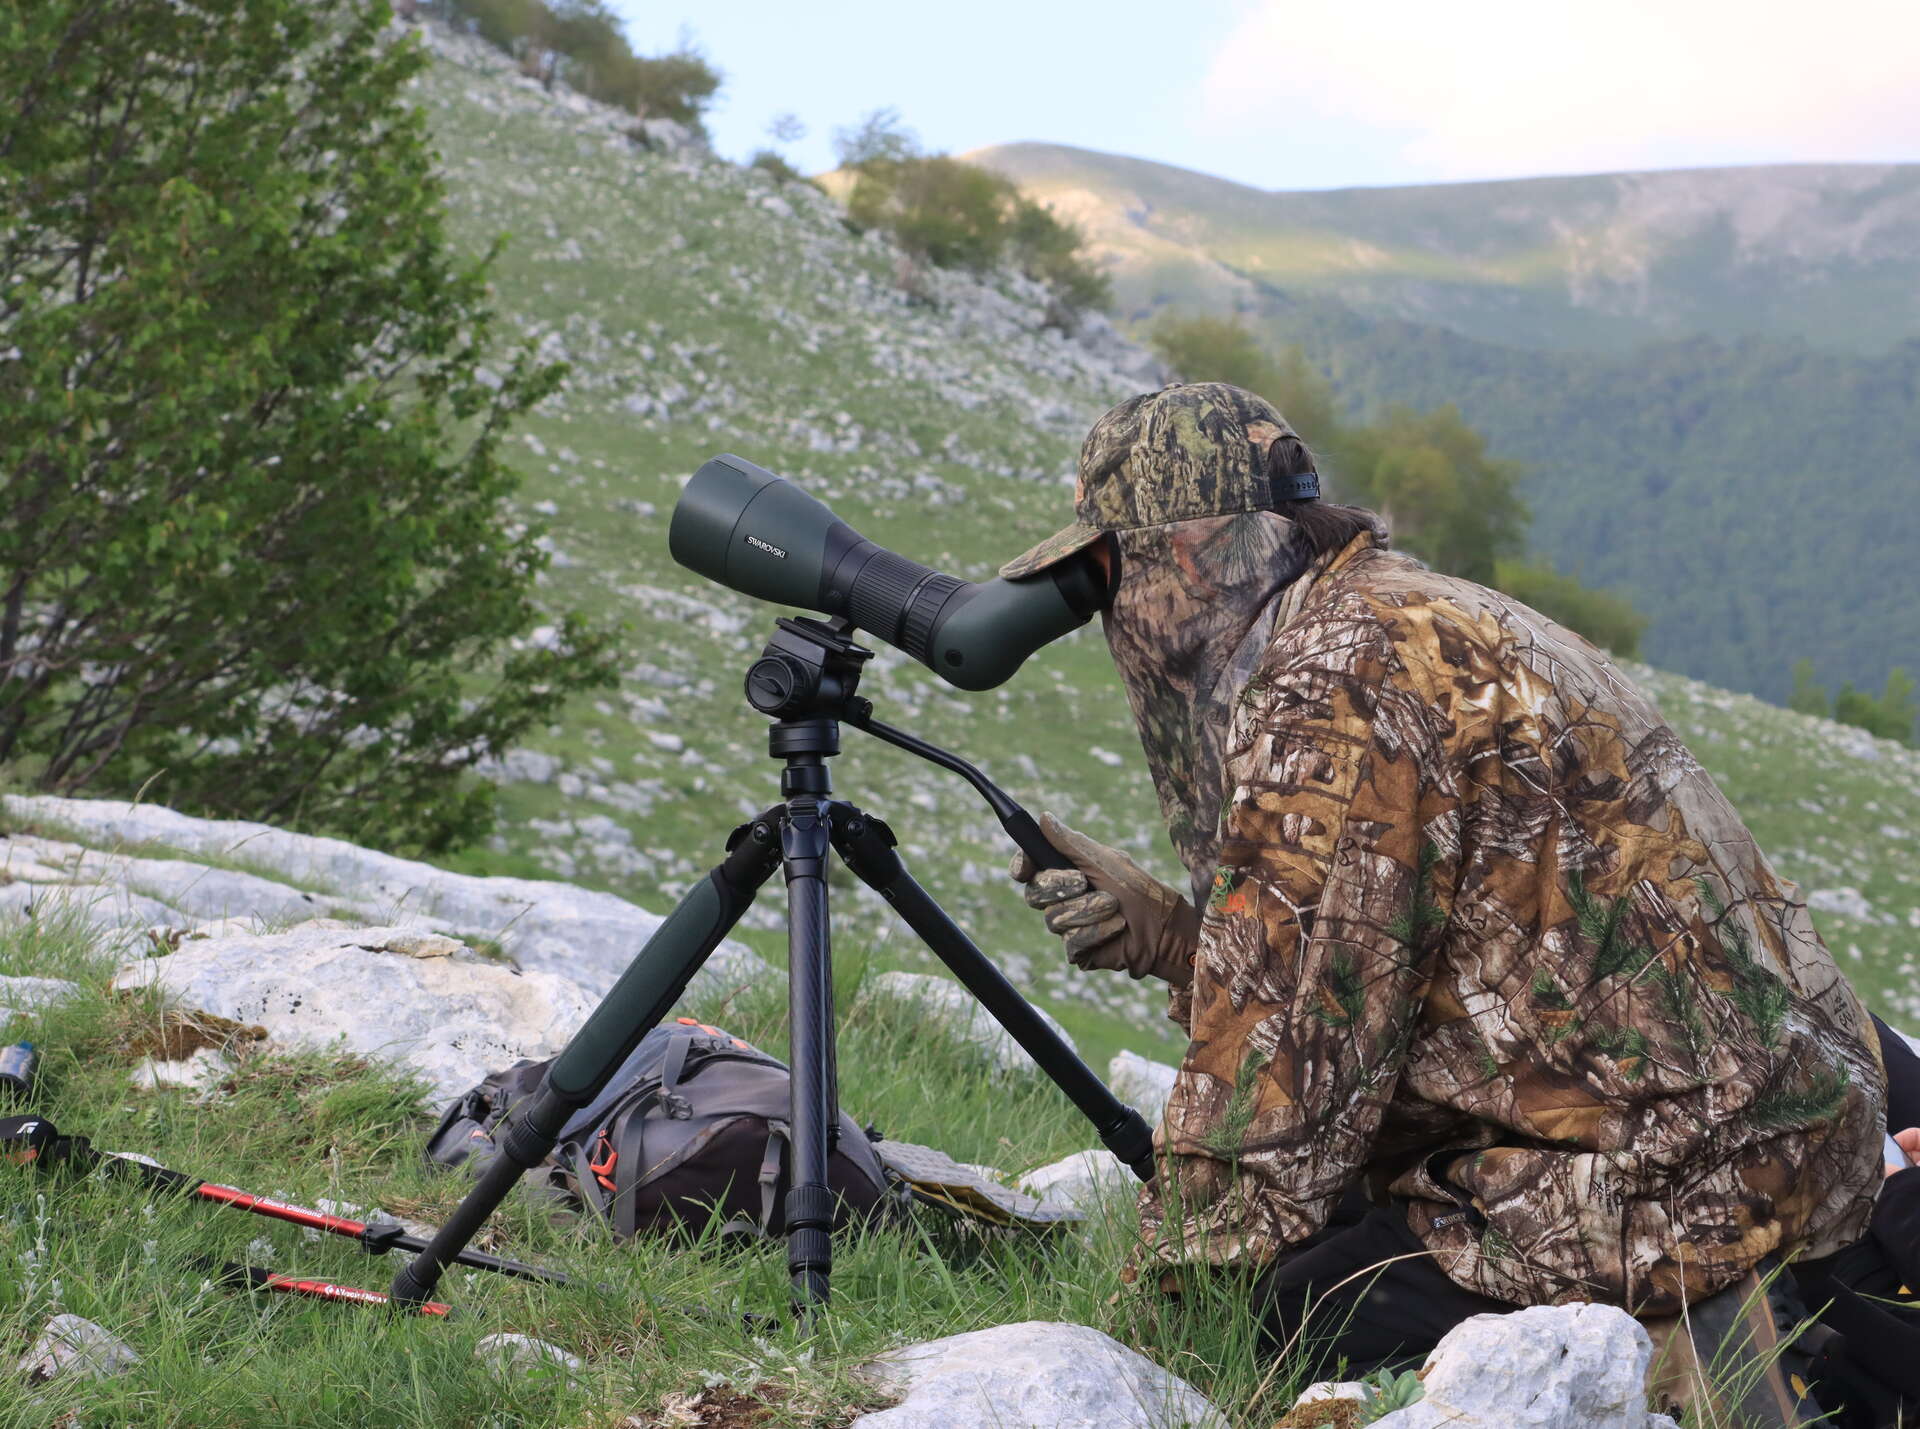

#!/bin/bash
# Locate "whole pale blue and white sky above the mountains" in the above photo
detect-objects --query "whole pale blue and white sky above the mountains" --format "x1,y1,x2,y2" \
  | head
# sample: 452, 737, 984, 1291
612, 0, 1920, 188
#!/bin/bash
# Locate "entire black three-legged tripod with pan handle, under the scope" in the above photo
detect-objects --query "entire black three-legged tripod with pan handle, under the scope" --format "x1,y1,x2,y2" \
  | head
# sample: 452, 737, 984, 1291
392, 617, 1154, 1314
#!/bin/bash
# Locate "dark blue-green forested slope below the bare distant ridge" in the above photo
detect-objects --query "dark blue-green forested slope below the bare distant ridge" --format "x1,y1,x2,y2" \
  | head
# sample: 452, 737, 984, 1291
1258, 292, 1920, 703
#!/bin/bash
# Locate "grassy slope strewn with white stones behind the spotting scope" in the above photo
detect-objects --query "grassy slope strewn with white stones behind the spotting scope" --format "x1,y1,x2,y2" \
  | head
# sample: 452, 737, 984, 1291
393, 22, 1920, 1062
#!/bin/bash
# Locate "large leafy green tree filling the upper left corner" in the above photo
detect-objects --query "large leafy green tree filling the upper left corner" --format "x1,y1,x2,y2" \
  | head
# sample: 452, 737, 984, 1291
0, 0, 612, 849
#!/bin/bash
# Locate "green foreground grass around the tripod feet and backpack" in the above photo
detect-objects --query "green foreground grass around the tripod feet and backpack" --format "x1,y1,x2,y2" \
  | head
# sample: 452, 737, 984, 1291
0, 920, 1292, 1429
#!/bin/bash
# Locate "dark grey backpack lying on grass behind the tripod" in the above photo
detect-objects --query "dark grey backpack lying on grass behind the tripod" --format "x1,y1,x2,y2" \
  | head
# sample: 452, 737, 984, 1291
426, 1018, 900, 1241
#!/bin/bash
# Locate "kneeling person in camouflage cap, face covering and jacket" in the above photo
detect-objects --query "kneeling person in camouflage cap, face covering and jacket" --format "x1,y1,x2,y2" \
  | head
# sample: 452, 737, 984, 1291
1002, 384, 1884, 1423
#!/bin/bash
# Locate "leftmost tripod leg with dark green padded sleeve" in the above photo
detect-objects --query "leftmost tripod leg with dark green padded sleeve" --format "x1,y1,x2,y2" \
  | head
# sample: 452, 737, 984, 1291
392, 809, 780, 1304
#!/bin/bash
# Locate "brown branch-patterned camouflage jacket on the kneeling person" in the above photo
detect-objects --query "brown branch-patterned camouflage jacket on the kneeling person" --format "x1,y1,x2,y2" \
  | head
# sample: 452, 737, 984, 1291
1142, 536, 1884, 1314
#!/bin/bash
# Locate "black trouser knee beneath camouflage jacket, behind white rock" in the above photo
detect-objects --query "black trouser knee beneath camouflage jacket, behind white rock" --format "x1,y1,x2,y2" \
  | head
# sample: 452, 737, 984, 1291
1254, 1195, 1519, 1379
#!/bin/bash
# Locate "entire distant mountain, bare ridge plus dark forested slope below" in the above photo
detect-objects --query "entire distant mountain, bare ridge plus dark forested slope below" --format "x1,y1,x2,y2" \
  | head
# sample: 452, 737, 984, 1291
973, 144, 1920, 699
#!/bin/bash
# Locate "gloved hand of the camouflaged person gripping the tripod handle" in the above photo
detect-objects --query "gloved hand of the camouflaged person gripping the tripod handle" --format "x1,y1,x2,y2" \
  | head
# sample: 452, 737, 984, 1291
1008, 814, 1200, 987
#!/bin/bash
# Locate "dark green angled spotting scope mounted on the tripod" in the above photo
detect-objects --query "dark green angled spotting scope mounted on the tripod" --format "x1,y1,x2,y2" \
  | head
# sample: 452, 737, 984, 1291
666, 455, 1112, 690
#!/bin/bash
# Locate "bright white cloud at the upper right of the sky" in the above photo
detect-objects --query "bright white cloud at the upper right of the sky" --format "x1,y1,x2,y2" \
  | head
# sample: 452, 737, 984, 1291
1200, 0, 1920, 179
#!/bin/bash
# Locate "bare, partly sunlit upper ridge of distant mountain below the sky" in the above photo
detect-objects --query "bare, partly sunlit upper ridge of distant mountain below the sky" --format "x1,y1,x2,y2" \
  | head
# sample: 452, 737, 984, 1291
966, 144, 1920, 351
